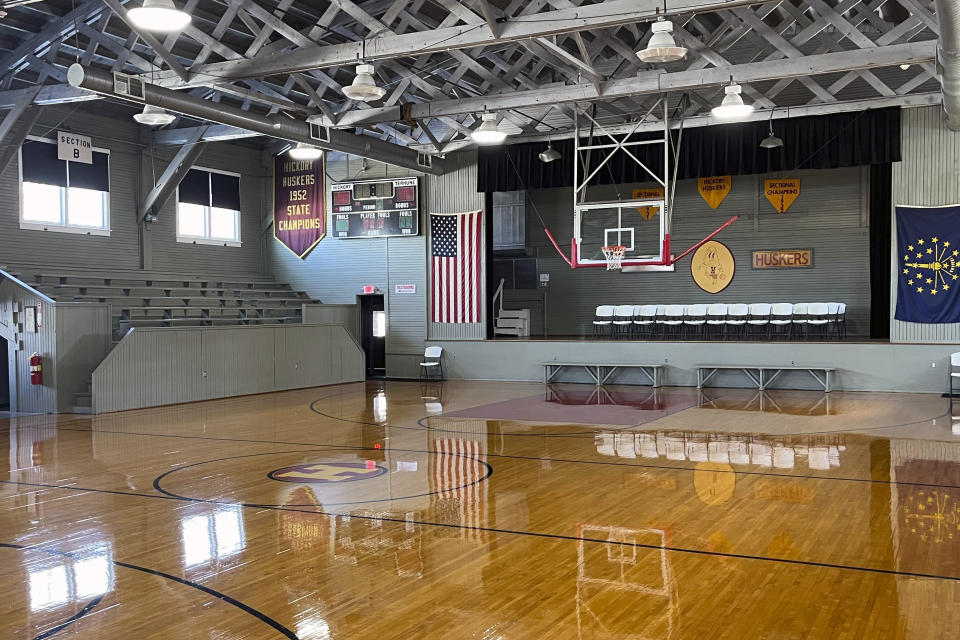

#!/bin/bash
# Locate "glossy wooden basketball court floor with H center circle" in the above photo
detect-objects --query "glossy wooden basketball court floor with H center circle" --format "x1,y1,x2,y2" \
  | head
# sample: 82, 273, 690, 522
0, 382, 960, 640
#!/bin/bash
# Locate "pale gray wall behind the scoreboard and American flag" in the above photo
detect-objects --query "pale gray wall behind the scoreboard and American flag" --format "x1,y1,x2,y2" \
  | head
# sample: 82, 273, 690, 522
266, 152, 485, 377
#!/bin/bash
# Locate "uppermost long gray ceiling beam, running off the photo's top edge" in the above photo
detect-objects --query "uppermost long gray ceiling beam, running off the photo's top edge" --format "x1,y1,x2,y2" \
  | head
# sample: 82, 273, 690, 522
157, 0, 780, 87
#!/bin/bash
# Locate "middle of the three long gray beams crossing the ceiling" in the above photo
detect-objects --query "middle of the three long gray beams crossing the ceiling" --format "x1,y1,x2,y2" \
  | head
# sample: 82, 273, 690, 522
324, 40, 936, 126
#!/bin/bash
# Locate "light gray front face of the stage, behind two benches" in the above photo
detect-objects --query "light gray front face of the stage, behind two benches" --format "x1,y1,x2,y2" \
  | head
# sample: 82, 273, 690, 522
428, 338, 960, 393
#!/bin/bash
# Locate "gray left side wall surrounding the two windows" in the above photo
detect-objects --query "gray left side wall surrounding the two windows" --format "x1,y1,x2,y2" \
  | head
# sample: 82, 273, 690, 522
0, 105, 269, 275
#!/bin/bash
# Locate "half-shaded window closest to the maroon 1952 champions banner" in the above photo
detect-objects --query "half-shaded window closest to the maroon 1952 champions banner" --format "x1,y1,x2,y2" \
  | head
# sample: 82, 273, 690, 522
177, 169, 240, 247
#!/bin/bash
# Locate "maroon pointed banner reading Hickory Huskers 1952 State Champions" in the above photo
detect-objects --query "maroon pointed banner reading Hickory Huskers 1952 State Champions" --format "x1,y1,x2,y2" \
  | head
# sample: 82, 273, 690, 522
273, 155, 327, 259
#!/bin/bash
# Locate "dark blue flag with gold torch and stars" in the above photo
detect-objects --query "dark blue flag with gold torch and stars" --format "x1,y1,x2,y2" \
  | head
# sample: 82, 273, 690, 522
894, 205, 960, 324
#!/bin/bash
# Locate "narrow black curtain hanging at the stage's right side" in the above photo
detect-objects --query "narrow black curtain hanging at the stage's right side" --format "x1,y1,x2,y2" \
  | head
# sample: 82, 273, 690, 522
870, 162, 892, 340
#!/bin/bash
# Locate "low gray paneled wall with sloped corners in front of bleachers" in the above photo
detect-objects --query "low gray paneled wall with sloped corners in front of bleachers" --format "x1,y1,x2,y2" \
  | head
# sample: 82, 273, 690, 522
93, 324, 364, 413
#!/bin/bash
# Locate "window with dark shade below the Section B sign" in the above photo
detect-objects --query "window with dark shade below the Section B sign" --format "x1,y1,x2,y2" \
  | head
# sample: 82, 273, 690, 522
20, 137, 110, 235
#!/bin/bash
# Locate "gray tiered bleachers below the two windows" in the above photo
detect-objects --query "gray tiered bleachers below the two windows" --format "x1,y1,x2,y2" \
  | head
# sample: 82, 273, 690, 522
11, 267, 319, 342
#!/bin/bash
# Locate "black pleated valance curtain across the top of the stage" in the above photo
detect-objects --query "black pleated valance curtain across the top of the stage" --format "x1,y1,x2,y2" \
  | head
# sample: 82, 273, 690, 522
477, 107, 900, 192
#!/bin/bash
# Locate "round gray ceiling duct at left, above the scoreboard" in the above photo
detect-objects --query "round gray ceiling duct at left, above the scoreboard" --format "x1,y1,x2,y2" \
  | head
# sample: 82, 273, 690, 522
67, 64, 444, 175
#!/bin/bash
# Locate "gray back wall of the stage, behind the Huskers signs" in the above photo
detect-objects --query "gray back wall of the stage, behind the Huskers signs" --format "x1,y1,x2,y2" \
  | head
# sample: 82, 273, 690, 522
524, 168, 870, 335
